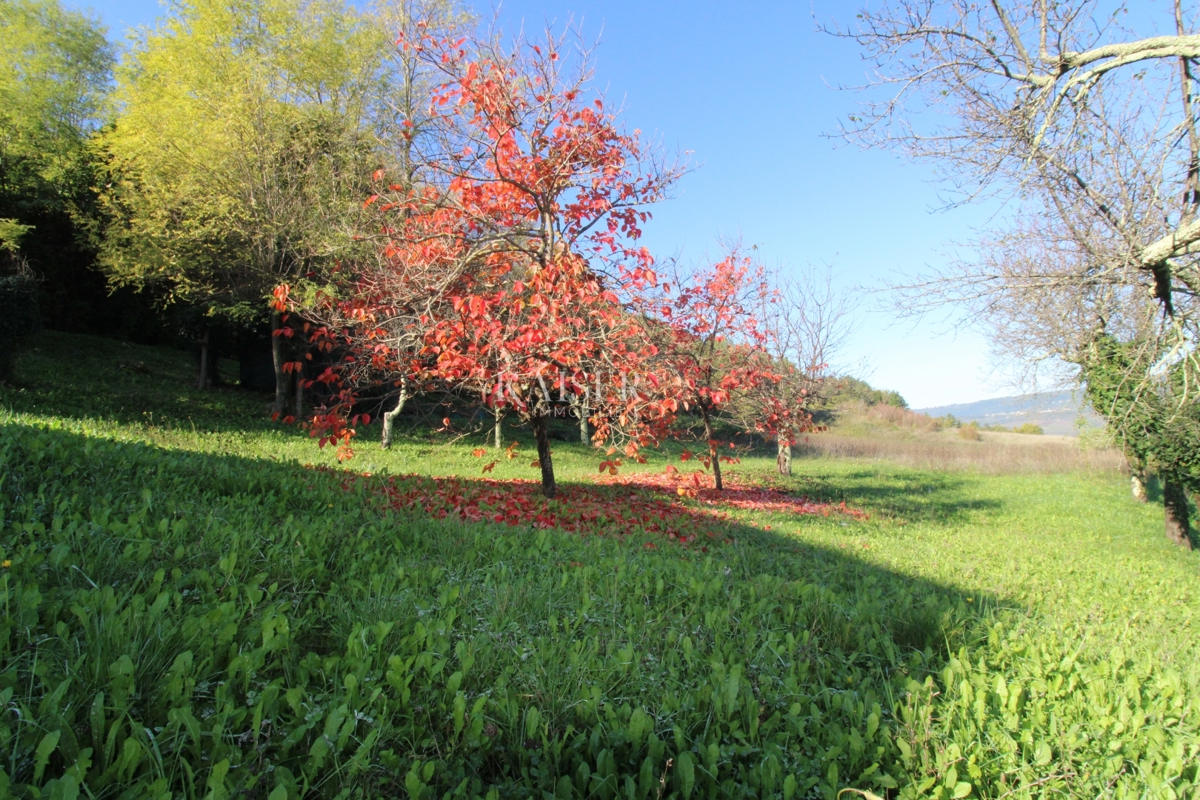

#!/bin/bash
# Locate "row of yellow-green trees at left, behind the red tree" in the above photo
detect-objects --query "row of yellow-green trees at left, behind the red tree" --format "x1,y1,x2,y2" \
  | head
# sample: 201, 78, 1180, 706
0, 0, 463, 400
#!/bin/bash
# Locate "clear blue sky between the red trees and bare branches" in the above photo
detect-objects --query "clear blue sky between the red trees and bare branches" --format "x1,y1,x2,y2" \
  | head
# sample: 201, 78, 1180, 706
65, 0, 1032, 408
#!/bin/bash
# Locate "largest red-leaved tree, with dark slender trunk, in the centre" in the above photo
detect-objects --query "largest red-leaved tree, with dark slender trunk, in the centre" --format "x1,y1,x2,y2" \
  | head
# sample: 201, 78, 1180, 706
274, 25, 682, 497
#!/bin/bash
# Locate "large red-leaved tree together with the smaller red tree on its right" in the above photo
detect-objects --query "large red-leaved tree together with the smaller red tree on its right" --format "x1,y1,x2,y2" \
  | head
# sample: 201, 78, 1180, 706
276, 26, 811, 498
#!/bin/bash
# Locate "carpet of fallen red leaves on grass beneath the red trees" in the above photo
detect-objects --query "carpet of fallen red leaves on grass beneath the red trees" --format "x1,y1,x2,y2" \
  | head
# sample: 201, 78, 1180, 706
324, 468, 866, 547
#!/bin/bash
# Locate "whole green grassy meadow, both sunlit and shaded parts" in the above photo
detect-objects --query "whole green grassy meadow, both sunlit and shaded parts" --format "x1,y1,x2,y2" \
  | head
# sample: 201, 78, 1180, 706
0, 333, 1200, 800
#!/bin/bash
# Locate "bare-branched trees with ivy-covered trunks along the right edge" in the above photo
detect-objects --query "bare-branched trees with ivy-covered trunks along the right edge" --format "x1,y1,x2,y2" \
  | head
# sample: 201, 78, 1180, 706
830, 0, 1200, 545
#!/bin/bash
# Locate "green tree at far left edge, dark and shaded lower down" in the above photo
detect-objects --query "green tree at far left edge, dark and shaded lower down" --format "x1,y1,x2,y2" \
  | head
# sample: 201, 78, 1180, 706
0, 0, 154, 331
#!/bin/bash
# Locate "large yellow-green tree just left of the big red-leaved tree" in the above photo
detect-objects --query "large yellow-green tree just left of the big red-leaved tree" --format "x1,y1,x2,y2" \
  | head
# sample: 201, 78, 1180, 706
100, 0, 395, 402
